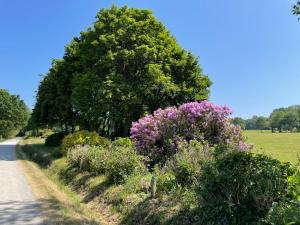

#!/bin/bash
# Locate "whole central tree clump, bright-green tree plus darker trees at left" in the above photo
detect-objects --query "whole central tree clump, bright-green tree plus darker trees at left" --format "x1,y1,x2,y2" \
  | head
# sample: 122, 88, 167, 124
31, 6, 211, 138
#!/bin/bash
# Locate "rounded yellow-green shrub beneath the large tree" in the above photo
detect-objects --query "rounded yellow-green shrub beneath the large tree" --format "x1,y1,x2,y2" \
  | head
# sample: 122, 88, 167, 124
61, 131, 110, 155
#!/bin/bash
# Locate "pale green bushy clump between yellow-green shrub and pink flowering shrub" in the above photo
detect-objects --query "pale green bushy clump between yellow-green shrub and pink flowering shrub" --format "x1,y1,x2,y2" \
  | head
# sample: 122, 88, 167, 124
67, 141, 146, 184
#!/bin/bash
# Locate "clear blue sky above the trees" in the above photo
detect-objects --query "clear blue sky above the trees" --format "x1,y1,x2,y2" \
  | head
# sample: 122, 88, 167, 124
0, 0, 300, 117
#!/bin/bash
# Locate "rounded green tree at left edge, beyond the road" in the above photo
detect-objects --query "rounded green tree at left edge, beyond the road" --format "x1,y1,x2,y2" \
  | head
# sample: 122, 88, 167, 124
0, 89, 29, 139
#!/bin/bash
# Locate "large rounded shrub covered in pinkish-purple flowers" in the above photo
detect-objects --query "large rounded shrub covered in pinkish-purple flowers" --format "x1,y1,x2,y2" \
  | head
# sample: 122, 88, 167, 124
130, 101, 247, 162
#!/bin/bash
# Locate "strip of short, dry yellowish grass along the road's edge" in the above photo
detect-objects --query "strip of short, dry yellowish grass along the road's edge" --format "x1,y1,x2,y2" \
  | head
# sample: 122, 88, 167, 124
17, 139, 110, 225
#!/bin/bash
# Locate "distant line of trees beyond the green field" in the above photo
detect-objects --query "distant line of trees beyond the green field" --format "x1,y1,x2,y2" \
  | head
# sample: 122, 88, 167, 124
232, 105, 300, 132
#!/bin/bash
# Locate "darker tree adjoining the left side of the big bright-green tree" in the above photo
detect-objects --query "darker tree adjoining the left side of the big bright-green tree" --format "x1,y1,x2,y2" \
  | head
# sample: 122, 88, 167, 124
31, 60, 75, 132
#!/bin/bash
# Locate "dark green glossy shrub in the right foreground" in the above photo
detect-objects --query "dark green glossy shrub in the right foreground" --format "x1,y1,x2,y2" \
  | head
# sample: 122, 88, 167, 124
197, 152, 292, 224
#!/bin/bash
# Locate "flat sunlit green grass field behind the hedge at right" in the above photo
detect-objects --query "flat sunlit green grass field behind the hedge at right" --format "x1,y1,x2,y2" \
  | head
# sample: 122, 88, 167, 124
244, 130, 300, 164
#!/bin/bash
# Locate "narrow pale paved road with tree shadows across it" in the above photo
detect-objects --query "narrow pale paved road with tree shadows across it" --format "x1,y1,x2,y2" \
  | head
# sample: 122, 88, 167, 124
0, 138, 43, 225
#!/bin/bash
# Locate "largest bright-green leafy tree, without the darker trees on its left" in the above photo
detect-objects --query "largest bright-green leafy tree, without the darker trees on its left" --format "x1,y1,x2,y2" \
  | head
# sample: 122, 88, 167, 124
72, 6, 211, 136
